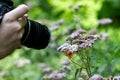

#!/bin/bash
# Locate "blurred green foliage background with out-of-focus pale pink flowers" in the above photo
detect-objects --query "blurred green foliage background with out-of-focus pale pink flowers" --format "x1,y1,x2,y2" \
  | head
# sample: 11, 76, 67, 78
0, 0, 120, 80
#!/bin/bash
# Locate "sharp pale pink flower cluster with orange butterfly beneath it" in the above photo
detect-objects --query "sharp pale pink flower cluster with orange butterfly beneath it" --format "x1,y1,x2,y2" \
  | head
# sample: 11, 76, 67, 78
57, 30, 100, 52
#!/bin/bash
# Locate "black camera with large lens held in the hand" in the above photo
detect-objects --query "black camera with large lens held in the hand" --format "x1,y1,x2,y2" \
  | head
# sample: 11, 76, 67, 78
0, 2, 50, 49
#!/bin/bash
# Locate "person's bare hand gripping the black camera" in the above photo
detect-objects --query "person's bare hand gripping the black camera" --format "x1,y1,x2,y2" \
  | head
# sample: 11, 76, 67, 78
0, 4, 29, 59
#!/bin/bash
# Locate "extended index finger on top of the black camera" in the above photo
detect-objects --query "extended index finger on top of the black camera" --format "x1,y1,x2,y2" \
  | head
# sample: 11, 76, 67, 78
5, 4, 29, 21
